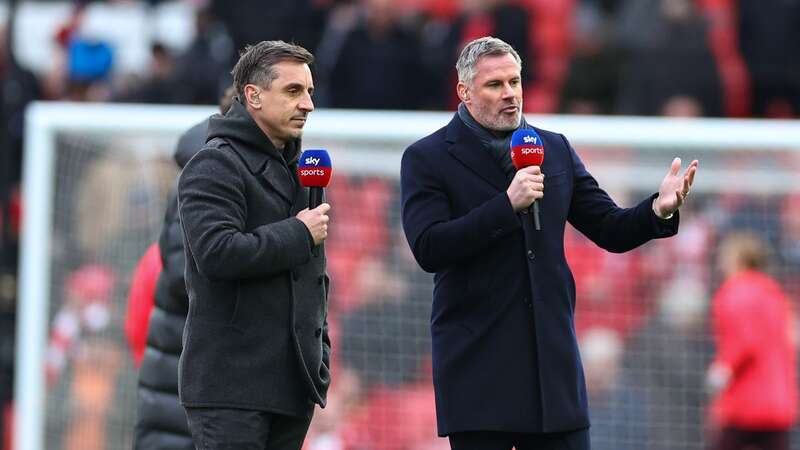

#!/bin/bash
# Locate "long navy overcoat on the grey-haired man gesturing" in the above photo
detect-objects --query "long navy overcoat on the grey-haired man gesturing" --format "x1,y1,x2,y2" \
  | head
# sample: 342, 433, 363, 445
401, 115, 678, 436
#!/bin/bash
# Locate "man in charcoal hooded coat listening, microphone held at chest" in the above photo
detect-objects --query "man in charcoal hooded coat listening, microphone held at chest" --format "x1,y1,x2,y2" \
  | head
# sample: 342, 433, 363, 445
178, 41, 330, 449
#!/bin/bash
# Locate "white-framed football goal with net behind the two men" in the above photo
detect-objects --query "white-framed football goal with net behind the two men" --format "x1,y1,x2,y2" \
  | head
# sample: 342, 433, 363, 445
14, 103, 800, 450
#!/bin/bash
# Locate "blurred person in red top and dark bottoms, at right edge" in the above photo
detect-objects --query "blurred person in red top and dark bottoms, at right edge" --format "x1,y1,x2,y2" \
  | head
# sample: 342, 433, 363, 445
706, 234, 798, 450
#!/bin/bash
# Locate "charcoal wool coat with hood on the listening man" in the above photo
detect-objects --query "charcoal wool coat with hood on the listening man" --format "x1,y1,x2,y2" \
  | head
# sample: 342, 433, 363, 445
178, 101, 330, 416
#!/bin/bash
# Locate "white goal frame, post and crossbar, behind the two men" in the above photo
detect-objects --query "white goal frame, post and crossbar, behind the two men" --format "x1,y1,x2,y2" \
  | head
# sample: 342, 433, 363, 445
14, 102, 800, 450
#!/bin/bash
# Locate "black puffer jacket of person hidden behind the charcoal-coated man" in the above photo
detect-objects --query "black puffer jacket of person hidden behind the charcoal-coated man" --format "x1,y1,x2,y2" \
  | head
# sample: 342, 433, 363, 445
134, 120, 208, 450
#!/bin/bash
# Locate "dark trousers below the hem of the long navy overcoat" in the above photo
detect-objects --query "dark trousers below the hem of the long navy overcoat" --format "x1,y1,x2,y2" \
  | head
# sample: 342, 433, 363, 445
448, 429, 591, 450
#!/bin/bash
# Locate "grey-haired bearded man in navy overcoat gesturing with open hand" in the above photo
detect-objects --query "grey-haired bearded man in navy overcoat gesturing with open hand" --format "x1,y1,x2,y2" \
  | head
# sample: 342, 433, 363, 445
401, 38, 697, 450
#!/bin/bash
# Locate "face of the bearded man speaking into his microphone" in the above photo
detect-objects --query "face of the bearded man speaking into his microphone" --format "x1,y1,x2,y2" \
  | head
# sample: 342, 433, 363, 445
458, 53, 522, 131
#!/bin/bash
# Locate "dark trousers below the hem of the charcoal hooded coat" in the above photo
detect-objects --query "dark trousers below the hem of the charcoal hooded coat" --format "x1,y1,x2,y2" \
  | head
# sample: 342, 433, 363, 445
186, 408, 313, 450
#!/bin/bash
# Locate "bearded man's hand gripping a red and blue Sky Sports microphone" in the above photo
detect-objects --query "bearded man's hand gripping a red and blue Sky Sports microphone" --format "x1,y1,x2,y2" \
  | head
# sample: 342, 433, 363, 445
506, 129, 544, 230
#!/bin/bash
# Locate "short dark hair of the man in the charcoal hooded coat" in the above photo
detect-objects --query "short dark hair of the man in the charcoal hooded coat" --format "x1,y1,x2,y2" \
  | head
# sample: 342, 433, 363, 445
231, 41, 314, 96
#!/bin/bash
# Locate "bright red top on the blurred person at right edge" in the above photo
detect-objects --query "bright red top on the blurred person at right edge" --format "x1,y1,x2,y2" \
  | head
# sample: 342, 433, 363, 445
712, 270, 798, 430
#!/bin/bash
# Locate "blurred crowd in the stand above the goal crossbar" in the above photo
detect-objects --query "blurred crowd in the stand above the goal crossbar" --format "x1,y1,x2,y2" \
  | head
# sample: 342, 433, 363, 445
4, 0, 800, 117
